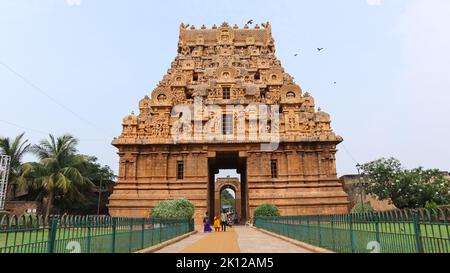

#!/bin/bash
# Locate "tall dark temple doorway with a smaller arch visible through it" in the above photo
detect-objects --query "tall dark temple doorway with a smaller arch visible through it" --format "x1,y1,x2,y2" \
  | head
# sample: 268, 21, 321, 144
208, 152, 248, 223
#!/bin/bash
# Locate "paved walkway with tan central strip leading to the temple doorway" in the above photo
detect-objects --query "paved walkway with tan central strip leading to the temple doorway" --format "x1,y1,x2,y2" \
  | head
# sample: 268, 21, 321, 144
157, 226, 310, 253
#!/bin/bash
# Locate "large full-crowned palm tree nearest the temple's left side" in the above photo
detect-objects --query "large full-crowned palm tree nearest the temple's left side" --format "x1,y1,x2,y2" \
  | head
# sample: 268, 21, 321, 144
19, 135, 92, 216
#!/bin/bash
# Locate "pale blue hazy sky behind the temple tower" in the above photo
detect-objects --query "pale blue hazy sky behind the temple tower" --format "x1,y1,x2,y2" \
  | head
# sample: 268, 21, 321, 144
0, 0, 450, 176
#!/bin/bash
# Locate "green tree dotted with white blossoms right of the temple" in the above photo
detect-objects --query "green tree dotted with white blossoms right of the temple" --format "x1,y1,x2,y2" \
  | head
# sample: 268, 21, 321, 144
362, 158, 450, 209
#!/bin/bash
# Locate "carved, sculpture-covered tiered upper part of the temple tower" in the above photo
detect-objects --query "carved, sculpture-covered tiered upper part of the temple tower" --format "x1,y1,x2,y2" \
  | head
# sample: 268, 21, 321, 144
113, 23, 342, 144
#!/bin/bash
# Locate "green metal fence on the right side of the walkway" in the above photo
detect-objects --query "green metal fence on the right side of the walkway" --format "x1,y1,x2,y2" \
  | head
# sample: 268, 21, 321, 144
255, 209, 450, 253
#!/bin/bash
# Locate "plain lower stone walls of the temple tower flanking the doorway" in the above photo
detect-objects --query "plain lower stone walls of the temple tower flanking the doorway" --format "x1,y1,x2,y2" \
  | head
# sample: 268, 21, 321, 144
109, 144, 349, 223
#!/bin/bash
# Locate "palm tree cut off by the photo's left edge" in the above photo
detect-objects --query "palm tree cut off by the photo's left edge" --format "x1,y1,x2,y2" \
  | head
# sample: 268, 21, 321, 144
0, 133, 31, 200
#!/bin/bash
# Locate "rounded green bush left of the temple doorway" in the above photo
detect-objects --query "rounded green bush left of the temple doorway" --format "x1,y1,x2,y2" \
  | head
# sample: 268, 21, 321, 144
152, 199, 194, 219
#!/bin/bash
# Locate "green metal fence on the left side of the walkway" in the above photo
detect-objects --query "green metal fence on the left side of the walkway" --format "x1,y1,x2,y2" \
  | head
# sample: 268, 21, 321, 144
0, 216, 194, 253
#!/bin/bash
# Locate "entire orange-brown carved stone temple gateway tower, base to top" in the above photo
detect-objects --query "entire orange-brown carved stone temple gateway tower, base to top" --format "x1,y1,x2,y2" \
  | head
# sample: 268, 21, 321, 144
109, 23, 348, 223
